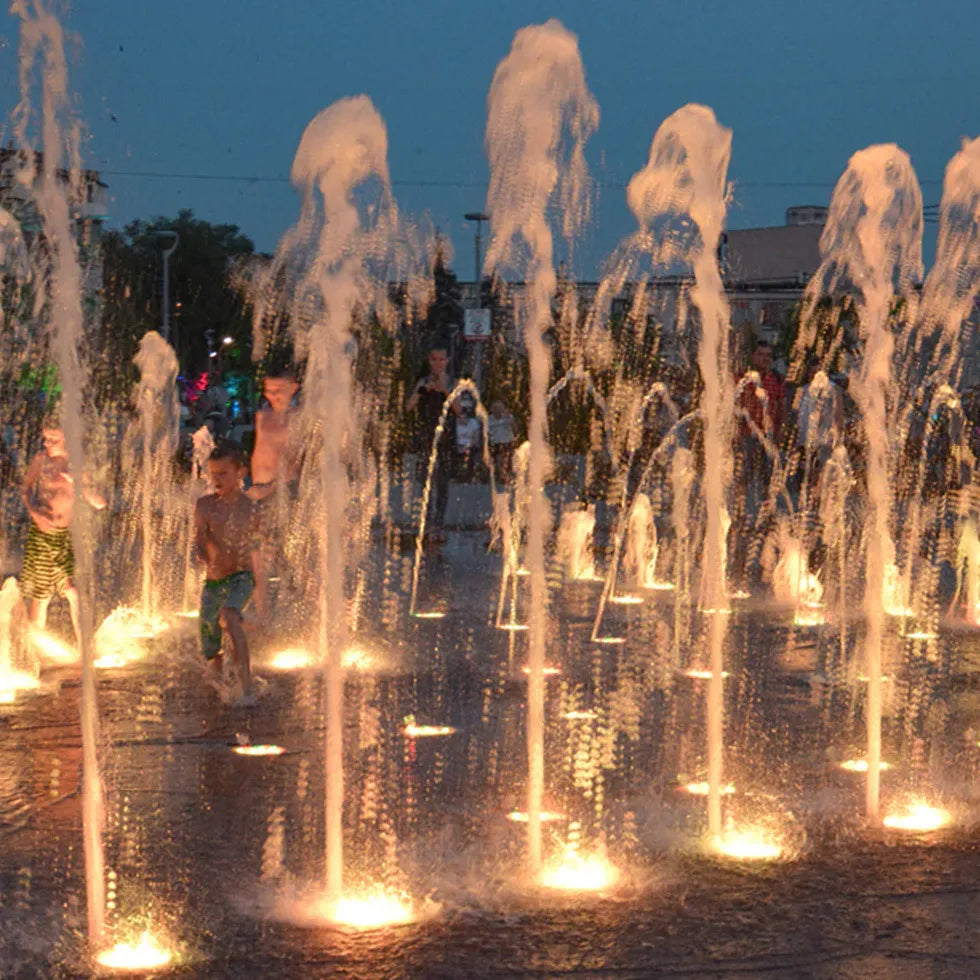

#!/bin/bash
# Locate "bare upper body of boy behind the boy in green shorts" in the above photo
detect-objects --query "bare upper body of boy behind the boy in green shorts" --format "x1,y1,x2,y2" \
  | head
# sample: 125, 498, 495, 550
248, 367, 299, 500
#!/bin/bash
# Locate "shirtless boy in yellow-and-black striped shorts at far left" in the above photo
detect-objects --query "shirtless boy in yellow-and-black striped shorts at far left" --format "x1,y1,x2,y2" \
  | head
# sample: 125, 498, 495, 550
20, 418, 105, 645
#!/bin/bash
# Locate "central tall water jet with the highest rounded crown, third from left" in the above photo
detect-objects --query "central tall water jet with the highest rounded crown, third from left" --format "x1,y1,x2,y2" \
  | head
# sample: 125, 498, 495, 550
484, 20, 599, 873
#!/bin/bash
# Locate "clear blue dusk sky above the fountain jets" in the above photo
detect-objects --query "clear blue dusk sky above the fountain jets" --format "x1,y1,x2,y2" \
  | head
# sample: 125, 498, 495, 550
0, 0, 980, 278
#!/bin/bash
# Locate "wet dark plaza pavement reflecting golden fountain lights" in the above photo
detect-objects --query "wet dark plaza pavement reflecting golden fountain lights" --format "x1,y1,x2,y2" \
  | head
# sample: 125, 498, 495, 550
0, 533, 980, 980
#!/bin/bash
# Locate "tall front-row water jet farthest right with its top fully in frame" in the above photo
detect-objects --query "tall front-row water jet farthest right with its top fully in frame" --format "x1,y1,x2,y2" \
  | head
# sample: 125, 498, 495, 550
807, 144, 922, 822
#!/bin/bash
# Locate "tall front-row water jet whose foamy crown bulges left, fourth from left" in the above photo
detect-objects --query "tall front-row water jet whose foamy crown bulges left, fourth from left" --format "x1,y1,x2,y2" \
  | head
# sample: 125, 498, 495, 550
627, 105, 733, 836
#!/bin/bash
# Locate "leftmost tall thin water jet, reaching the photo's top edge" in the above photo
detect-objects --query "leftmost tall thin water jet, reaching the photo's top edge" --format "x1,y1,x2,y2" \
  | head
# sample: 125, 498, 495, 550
11, 0, 105, 946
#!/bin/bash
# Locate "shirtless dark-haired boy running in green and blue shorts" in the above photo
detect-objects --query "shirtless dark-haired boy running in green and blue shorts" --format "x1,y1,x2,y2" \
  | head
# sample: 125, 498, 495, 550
194, 442, 266, 698
